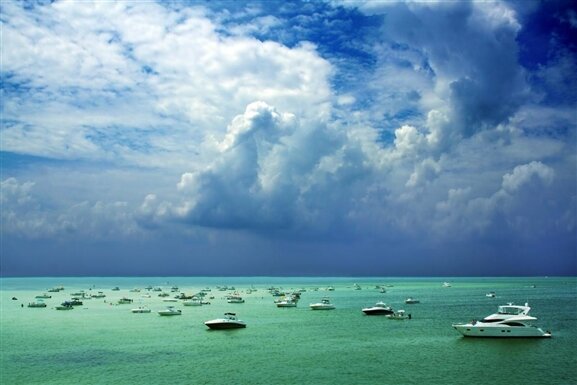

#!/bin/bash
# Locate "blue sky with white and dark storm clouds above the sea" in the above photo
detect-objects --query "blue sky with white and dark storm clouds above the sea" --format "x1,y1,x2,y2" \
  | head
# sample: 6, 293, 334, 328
0, 0, 577, 276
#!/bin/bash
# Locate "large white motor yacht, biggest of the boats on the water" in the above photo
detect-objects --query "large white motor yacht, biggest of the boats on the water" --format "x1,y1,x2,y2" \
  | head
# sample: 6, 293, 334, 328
453, 303, 551, 338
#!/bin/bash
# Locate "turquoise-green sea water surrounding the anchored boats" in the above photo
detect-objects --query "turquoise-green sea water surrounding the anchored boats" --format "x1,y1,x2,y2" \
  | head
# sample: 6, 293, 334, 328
0, 277, 577, 385
